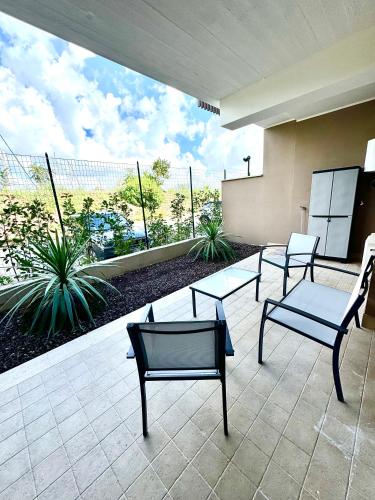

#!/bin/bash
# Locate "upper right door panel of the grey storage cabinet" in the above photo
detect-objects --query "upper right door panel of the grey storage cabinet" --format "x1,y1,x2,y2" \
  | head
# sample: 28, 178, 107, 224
329, 168, 358, 215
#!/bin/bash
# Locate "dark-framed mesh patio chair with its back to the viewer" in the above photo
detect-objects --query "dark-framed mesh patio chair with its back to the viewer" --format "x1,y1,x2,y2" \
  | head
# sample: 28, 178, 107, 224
127, 302, 230, 436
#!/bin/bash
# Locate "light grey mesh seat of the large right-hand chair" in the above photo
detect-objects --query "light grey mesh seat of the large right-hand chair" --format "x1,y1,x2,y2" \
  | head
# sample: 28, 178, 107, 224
268, 280, 351, 346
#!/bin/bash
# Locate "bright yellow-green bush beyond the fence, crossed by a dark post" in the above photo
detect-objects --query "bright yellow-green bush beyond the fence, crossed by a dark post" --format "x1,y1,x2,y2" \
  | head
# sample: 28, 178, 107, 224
119, 173, 164, 214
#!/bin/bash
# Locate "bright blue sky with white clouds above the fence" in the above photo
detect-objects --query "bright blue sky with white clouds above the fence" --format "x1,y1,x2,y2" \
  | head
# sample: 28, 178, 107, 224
0, 13, 263, 182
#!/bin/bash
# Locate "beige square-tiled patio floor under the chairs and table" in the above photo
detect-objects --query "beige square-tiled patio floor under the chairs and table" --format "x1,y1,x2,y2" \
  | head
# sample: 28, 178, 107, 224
0, 256, 375, 500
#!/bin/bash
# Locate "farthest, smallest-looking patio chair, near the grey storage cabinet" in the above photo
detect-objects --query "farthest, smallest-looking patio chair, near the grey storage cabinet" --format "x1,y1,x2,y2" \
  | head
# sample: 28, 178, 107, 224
258, 233, 319, 295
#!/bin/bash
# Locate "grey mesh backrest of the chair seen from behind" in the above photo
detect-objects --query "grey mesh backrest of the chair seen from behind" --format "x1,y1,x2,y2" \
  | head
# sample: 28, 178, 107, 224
128, 321, 226, 371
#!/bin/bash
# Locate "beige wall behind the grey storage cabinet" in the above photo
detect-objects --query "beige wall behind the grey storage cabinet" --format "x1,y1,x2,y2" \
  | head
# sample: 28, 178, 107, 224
222, 100, 375, 258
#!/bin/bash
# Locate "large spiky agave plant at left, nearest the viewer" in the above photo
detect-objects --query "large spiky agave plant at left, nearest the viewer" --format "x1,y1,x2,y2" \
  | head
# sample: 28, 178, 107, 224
2, 233, 117, 336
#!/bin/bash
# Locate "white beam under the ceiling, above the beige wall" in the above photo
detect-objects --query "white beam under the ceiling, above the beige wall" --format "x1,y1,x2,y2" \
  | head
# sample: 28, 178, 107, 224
220, 26, 375, 130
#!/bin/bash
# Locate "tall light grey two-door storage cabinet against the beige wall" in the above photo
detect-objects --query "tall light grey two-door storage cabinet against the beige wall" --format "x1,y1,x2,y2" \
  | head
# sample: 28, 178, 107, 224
308, 167, 360, 259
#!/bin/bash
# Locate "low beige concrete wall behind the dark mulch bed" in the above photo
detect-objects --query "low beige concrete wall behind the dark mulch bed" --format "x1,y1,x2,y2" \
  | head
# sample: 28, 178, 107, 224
0, 238, 199, 311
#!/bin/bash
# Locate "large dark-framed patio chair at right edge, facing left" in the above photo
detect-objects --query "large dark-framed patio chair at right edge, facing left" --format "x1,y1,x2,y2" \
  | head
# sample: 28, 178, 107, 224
258, 255, 375, 401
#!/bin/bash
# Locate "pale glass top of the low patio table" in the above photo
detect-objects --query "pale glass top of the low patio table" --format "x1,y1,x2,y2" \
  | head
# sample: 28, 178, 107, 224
190, 267, 260, 300
